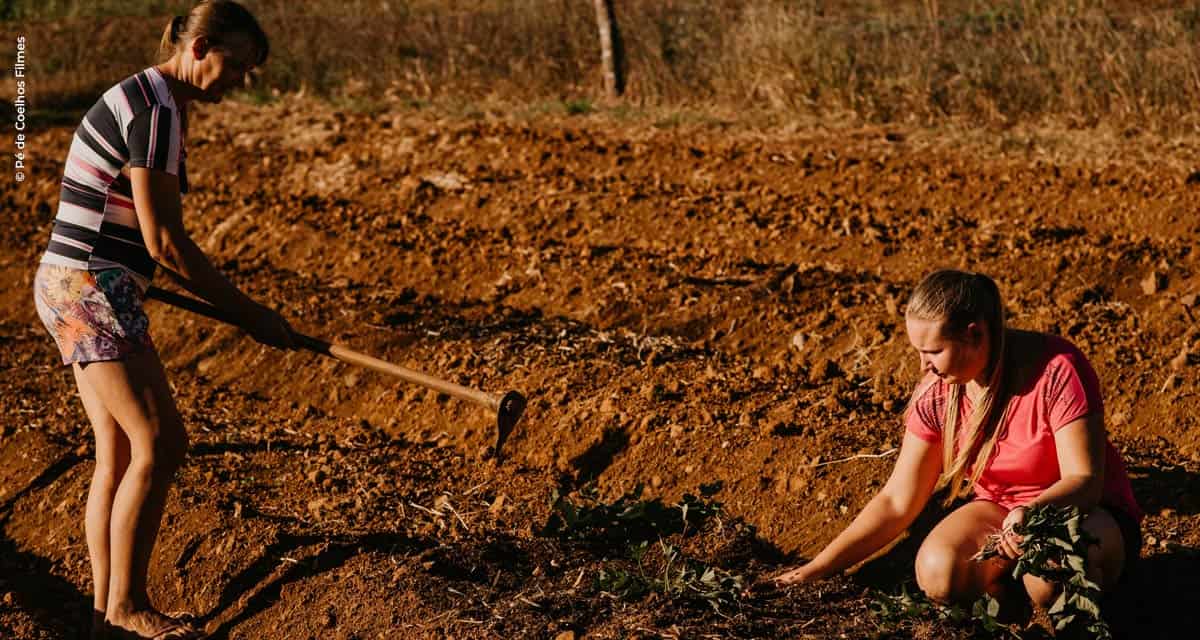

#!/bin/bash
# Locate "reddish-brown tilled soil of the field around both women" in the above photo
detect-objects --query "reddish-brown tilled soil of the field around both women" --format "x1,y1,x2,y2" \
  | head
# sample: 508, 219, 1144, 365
0, 98, 1200, 639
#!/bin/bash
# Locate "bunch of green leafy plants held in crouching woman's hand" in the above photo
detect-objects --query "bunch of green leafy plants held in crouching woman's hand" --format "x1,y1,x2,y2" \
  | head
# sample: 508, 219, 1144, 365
976, 504, 1112, 639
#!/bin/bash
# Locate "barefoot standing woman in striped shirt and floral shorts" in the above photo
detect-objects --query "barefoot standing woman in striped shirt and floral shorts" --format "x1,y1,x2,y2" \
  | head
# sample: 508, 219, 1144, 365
34, 0, 292, 640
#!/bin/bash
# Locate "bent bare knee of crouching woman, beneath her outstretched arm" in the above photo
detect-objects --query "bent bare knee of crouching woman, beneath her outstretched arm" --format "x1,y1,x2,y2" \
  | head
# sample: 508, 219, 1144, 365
917, 501, 1013, 604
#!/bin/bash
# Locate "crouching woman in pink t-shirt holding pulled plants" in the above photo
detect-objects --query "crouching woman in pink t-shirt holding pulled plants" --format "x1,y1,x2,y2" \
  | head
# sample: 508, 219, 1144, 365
774, 270, 1142, 608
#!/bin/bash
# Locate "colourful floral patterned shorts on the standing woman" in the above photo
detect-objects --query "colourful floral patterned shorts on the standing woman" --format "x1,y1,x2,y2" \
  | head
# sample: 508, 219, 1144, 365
34, 263, 154, 364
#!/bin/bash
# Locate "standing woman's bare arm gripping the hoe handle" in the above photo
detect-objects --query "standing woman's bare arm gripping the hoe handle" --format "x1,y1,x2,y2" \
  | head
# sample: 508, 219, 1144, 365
130, 167, 293, 347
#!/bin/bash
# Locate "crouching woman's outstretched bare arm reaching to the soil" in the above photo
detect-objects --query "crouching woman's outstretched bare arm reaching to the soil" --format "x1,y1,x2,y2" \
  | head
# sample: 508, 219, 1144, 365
775, 433, 942, 584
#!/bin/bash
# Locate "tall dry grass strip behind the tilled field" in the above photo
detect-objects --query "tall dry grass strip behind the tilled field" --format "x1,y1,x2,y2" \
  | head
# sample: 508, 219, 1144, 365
4, 0, 1200, 132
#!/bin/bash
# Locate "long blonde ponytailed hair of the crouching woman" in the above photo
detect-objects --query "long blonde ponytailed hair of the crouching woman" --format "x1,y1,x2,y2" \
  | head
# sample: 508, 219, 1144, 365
905, 269, 1012, 504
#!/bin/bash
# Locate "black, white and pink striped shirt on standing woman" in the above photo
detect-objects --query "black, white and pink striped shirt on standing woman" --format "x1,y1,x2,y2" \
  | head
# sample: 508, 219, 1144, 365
42, 67, 187, 288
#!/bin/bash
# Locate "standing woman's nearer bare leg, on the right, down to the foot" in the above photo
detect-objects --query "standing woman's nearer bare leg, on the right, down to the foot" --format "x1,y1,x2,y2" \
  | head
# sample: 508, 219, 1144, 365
72, 351, 187, 635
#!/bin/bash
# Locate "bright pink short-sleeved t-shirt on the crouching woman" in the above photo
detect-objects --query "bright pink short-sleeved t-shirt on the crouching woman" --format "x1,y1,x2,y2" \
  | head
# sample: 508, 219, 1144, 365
906, 336, 1142, 520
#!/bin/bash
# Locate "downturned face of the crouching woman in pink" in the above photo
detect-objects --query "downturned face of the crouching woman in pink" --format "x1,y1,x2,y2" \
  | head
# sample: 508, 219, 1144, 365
905, 317, 990, 384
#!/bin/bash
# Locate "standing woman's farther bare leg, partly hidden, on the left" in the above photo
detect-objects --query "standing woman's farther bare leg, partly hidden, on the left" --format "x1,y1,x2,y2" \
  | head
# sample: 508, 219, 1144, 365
73, 364, 130, 611
